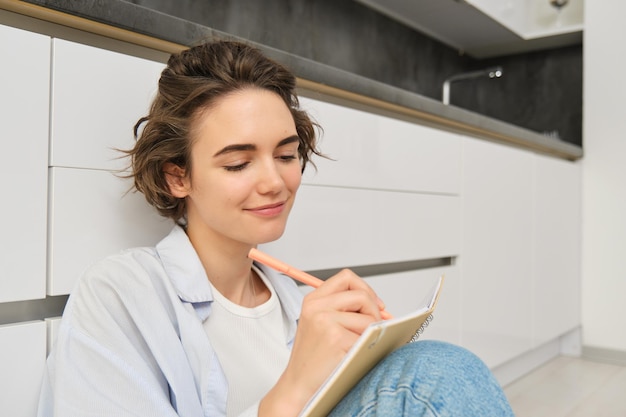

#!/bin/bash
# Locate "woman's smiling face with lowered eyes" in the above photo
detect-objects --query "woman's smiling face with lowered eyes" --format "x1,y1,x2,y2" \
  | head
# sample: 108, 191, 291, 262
173, 88, 301, 245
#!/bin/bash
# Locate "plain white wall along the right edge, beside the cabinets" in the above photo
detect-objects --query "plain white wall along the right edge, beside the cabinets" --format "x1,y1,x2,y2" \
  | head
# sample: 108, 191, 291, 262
582, 0, 626, 351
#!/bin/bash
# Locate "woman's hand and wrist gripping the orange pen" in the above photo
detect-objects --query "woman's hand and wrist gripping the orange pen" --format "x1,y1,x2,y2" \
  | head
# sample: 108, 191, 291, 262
259, 269, 382, 417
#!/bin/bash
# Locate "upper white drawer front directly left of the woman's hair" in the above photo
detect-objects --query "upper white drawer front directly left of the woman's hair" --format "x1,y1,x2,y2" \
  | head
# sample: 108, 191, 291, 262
50, 39, 164, 169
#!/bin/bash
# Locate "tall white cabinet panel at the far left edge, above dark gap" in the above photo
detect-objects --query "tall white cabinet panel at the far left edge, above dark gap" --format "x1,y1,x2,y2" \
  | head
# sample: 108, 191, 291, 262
0, 25, 50, 302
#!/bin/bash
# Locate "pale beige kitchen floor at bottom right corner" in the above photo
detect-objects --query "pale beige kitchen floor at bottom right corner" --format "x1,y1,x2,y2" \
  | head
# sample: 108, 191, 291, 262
504, 356, 626, 417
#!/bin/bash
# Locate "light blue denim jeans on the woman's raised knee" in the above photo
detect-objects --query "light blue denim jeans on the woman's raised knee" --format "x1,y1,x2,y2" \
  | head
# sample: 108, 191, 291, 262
329, 340, 513, 417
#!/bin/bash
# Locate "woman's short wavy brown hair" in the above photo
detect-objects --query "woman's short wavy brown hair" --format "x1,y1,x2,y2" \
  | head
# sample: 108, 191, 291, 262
126, 40, 320, 222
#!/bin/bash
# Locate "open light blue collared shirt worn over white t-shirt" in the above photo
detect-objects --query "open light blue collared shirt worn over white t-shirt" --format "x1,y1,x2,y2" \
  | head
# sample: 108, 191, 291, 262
39, 226, 302, 417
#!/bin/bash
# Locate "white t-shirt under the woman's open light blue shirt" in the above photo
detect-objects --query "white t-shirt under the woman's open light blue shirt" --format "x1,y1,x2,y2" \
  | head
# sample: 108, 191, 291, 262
203, 267, 291, 416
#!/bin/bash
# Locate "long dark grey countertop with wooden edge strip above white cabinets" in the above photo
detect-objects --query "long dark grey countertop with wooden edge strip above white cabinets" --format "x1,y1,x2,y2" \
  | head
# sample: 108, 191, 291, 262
8, 0, 583, 160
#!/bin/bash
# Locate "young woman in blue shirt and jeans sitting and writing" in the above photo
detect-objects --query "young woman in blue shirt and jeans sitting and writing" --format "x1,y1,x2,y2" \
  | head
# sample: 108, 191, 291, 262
39, 41, 512, 417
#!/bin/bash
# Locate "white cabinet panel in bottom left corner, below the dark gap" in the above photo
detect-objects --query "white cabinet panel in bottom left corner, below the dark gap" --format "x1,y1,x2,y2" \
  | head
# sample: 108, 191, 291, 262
0, 321, 46, 417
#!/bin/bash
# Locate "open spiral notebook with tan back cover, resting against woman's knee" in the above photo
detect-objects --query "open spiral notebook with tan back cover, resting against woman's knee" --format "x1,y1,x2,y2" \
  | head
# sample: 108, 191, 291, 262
300, 275, 444, 417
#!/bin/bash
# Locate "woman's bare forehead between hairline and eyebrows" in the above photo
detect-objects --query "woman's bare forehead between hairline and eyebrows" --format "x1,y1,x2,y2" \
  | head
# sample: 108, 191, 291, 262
192, 88, 296, 148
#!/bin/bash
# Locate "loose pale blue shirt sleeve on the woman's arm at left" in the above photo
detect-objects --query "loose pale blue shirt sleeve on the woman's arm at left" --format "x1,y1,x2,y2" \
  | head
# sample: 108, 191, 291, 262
38, 255, 203, 417
